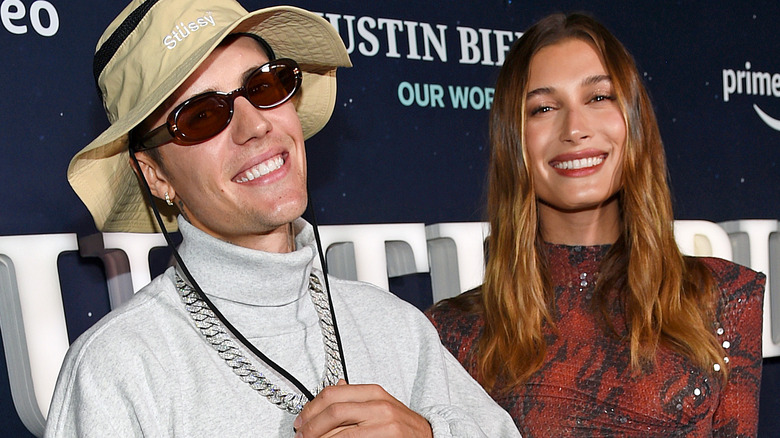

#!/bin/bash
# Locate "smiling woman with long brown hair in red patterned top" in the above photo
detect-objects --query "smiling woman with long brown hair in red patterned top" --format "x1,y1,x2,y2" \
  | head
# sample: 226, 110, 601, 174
429, 15, 765, 437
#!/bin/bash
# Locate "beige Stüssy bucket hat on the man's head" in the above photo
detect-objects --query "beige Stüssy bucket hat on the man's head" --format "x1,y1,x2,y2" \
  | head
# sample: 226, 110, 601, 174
68, 0, 352, 232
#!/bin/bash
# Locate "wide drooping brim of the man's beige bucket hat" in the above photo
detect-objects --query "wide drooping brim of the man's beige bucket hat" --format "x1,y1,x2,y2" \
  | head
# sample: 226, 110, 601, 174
68, 6, 351, 232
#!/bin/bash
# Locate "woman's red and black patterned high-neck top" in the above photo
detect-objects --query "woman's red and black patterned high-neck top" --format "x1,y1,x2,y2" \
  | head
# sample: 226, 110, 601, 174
428, 245, 765, 437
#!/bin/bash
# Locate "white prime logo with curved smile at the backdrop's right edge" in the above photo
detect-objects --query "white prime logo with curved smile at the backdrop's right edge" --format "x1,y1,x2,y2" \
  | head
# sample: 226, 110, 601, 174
723, 62, 780, 131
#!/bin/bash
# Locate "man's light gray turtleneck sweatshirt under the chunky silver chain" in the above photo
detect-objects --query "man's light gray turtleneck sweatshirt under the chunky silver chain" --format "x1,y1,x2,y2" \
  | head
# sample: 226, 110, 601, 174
45, 218, 519, 438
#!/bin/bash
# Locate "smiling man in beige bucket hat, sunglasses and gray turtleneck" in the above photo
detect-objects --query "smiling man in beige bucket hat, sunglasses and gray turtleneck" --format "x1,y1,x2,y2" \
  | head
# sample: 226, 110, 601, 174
41, 0, 519, 437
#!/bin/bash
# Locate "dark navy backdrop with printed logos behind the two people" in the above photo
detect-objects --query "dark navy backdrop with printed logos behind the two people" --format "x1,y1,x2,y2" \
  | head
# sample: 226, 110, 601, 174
0, 0, 780, 437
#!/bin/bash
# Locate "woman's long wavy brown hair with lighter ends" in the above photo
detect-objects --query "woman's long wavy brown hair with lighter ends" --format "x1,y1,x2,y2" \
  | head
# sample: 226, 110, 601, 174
464, 14, 726, 390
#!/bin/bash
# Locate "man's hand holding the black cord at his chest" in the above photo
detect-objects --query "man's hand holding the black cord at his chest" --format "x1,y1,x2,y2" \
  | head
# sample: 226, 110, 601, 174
294, 380, 433, 438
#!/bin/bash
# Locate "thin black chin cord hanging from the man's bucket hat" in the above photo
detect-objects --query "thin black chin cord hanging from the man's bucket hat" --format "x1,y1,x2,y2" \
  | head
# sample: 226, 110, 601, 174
130, 143, 349, 401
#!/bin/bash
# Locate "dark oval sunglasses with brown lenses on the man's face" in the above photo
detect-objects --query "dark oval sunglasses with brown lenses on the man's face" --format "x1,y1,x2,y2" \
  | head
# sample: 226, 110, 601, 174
134, 59, 303, 151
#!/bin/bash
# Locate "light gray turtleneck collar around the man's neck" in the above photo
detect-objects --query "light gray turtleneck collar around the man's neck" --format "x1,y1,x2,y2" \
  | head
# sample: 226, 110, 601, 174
179, 216, 317, 306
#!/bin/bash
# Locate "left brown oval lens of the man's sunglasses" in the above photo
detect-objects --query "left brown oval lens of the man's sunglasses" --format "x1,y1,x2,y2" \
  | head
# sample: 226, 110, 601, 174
176, 94, 231, 142
